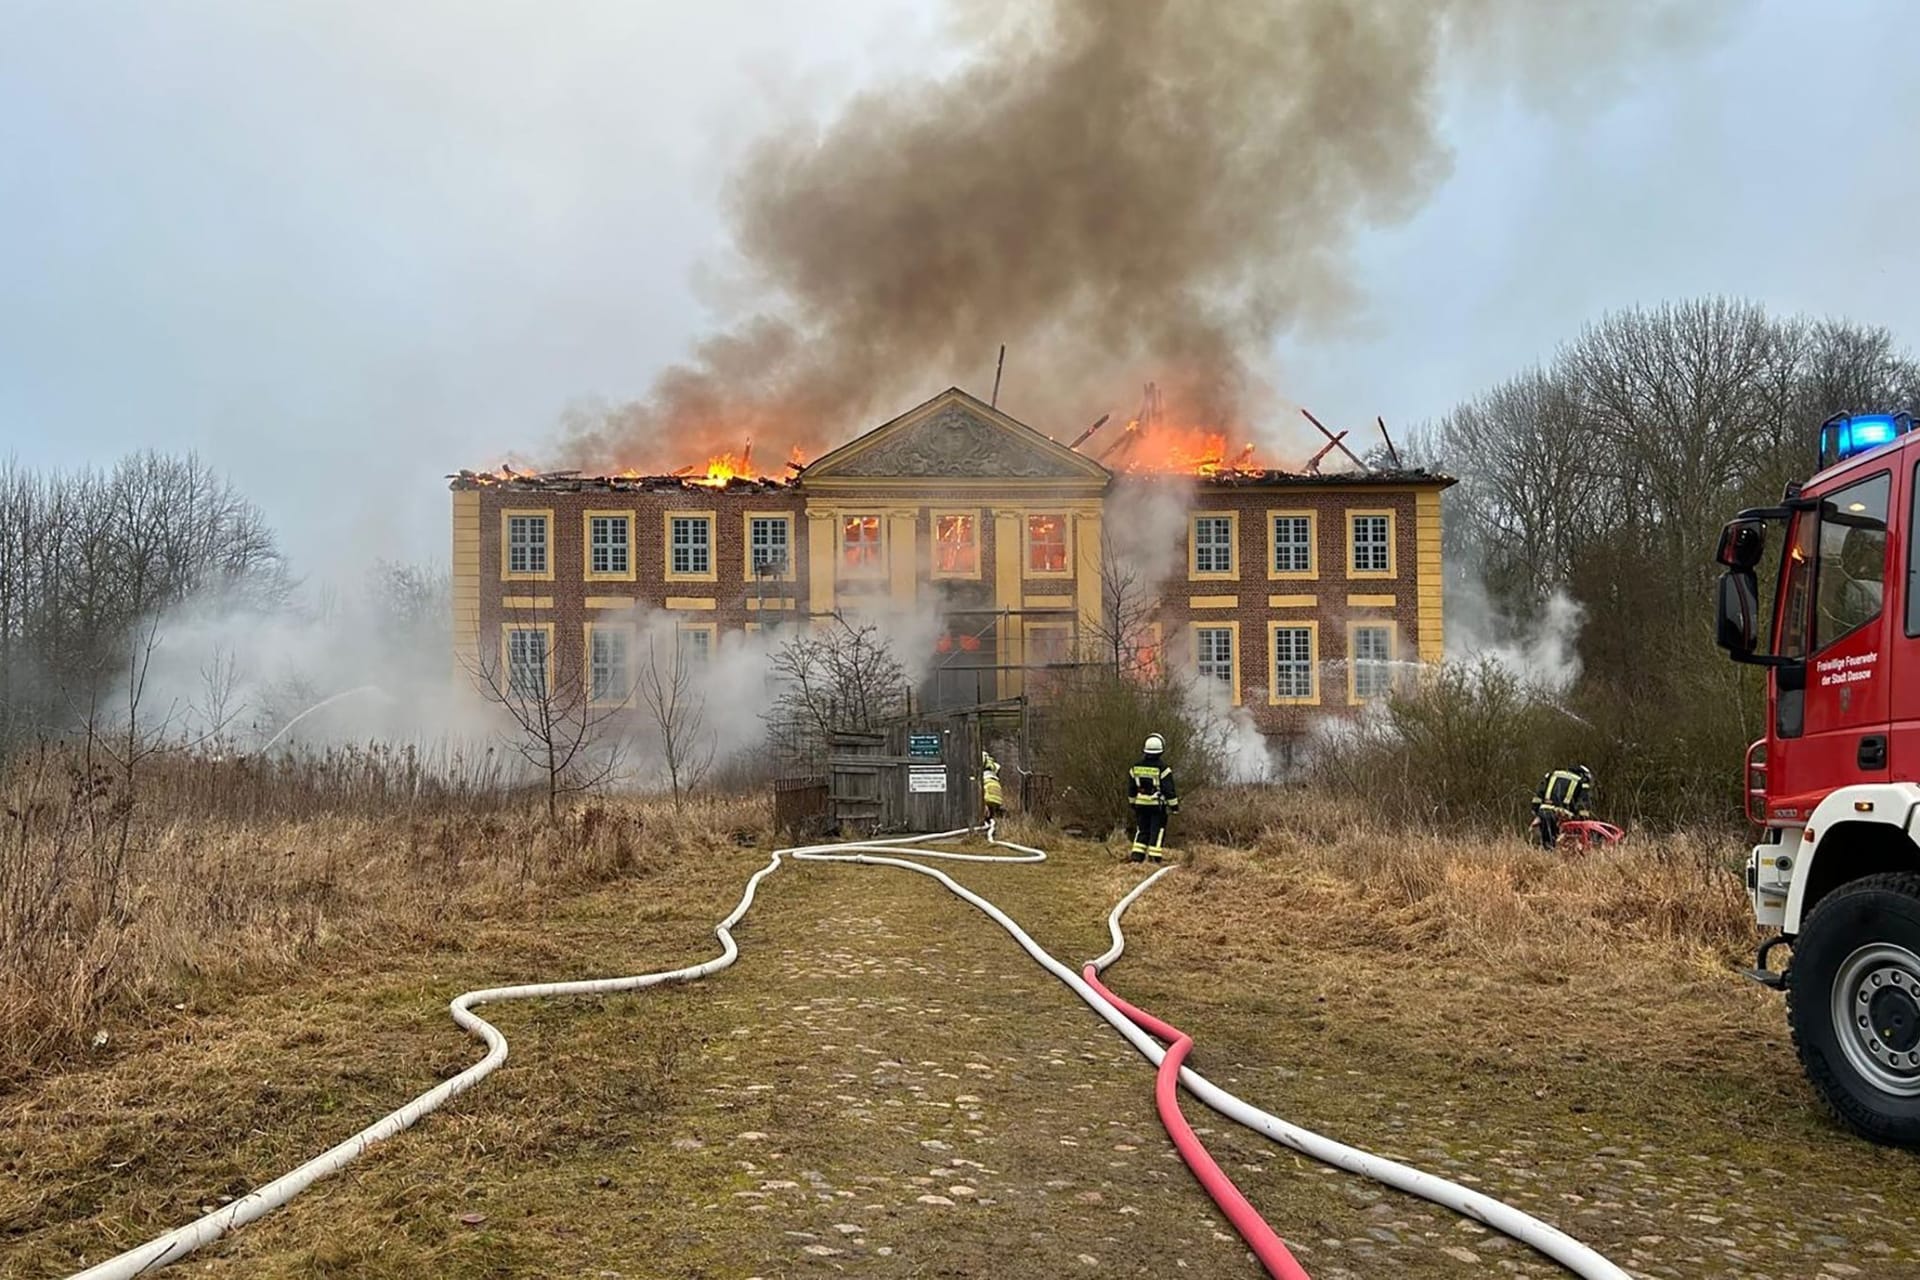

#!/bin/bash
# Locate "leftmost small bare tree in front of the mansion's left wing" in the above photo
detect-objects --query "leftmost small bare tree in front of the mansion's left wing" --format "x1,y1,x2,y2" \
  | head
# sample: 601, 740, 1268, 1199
467, 626, 632, 823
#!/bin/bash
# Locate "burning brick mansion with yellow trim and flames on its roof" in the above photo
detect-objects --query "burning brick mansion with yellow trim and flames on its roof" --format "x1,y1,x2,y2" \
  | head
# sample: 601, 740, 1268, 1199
451, 388, 1452, 733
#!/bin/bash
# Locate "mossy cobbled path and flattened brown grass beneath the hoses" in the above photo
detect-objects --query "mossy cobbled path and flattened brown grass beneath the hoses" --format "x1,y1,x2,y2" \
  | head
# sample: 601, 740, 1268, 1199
0, 800, 1920, 1280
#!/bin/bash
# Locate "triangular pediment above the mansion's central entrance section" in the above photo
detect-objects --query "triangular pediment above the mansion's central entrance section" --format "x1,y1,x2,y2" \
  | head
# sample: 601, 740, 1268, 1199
801, 388, 1108, 486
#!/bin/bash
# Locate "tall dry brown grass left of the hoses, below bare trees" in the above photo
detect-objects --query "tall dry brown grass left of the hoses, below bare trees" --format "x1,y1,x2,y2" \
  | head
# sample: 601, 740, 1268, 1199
0, 748, 766, 1084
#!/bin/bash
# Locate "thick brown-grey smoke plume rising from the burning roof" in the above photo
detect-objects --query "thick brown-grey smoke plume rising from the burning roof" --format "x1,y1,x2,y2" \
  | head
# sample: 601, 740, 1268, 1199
563, 0, 1724, 468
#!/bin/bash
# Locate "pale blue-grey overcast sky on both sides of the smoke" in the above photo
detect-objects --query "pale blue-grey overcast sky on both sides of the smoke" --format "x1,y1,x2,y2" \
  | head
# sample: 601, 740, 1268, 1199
0, 0, 1920, 574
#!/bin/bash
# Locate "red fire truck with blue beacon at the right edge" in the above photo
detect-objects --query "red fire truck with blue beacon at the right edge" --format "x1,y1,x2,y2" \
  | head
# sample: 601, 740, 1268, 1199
1716, 415, 1920, 1148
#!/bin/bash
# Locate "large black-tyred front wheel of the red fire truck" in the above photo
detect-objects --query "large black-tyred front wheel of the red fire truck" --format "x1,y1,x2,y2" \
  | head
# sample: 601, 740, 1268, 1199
1786, 873, 1920, 1148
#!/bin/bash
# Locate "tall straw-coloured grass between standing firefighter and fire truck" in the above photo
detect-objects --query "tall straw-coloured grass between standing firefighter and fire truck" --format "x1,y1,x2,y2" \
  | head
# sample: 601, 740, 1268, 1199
1142, 791, 1778, 1061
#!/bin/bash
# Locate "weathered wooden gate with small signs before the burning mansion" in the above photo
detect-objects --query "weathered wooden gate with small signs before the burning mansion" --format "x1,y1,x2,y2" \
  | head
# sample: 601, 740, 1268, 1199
828, 714, 981, 837
